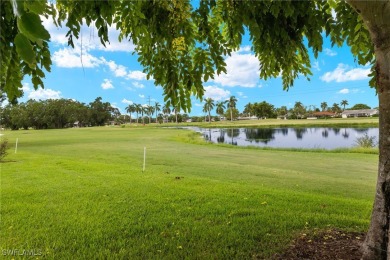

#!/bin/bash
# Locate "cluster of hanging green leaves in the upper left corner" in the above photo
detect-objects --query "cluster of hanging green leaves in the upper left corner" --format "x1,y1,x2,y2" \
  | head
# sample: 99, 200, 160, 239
0, 0, 54, 102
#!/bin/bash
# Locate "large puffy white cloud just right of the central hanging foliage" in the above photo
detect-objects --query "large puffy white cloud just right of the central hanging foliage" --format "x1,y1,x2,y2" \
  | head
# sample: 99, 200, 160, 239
213, 53, 260, 88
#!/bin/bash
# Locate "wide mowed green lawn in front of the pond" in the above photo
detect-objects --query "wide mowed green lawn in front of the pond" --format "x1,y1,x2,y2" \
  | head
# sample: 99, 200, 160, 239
0, 126, 378, 259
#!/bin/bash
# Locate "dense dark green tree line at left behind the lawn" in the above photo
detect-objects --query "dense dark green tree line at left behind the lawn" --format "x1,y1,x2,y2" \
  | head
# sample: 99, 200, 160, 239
0, 97, 120, 130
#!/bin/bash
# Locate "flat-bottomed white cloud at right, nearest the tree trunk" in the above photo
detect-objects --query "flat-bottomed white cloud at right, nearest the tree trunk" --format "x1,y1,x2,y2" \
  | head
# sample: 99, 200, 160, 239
321, 63, 370, 82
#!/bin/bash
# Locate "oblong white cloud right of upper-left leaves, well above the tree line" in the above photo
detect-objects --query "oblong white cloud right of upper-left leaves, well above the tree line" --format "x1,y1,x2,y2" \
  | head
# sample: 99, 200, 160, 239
52, 48, 102, 68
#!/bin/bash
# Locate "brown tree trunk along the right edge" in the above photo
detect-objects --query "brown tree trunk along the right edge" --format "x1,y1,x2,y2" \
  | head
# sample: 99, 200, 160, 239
349, 0, 390, 259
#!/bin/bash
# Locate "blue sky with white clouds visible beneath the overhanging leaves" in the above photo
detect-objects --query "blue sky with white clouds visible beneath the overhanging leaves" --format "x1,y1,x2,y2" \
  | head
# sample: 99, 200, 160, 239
19, 16, 378, 116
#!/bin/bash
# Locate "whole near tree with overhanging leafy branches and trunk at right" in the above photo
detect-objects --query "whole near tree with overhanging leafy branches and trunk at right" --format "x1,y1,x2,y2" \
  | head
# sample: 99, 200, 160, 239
0, 0, 390, 259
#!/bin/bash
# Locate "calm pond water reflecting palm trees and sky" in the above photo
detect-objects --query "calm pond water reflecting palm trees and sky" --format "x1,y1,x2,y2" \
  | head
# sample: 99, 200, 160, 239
191, 127, 379, 149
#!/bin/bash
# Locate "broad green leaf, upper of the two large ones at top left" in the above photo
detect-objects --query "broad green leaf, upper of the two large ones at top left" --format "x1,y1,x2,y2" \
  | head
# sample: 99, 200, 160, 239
18, 13, 50, 42
